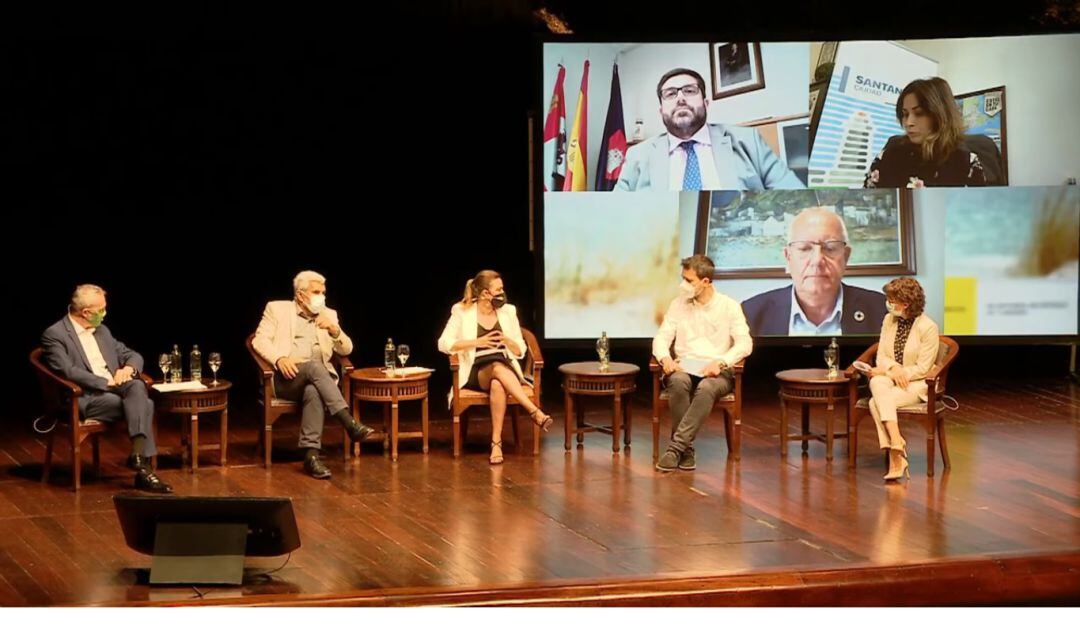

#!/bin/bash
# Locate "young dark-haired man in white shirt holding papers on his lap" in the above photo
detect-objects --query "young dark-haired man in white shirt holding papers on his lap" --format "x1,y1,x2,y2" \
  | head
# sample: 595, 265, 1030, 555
652, 255, 754, 473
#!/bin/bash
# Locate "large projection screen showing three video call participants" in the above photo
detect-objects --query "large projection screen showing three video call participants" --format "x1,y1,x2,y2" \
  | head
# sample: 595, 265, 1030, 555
540, 35, 1080, 339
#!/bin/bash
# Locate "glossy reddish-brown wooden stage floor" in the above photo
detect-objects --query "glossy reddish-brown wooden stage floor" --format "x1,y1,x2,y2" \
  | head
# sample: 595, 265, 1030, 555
0, 380, 1080, 606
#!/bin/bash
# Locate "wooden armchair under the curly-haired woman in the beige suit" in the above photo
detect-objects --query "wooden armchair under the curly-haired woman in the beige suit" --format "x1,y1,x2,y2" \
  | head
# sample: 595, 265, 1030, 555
845, 336, 960, 477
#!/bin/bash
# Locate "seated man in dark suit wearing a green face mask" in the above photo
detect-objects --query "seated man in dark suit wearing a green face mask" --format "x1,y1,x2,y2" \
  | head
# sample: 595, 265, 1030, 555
41, 284, 173, 492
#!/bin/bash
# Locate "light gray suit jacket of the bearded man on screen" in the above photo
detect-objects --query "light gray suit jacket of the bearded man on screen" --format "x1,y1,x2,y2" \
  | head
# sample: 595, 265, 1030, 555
615, 124, 806, 191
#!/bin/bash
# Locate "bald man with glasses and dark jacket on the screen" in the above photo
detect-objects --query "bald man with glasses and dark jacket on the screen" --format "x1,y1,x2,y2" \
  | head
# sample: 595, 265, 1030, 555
743, 208, 886, 337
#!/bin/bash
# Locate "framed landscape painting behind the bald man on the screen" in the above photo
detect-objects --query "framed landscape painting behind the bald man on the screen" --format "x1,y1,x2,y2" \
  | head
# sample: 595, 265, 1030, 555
694, 189, 915, 280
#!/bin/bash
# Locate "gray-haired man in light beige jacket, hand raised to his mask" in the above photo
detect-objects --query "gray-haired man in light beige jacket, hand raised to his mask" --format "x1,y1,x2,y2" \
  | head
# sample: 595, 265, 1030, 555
252, 271, 375, 479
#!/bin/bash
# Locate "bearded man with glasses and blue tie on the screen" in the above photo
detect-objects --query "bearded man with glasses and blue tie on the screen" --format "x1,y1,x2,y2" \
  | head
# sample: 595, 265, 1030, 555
615, 69, 806, 191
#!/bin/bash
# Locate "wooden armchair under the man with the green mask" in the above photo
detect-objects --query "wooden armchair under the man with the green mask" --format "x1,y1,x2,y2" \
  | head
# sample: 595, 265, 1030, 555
30, 348, 157, 491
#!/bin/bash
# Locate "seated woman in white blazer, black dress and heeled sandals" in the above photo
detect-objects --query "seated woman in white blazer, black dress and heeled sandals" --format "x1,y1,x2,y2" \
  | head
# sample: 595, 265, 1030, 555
438, 270, 552, 464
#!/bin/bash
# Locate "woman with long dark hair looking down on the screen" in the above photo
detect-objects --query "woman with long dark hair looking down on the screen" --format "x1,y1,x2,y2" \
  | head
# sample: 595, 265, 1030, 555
863, 78, 998, 189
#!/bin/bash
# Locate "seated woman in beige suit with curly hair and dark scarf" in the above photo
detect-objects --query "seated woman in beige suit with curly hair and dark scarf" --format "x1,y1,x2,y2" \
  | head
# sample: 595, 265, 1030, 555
869, 277, 939, 481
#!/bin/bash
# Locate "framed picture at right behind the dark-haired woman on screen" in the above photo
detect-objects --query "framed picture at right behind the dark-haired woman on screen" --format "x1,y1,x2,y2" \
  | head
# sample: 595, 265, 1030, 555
955, 86, 1009, 186
